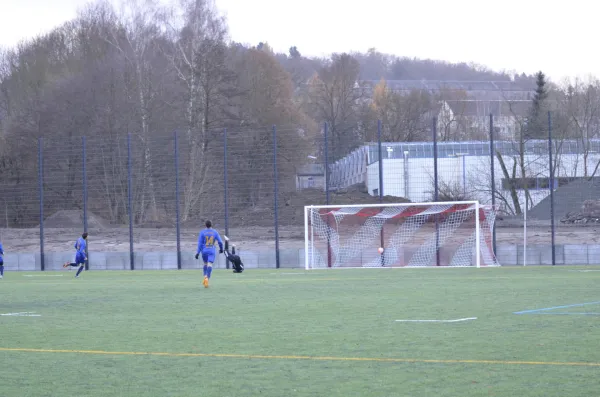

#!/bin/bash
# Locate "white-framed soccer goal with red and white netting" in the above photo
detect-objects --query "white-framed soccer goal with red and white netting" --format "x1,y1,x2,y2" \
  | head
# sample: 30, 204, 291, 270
304, 201, 499, 269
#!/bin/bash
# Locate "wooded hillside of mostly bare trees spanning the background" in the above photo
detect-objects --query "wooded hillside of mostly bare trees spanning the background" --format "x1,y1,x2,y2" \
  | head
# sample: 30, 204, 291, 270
0, 0, 600, 225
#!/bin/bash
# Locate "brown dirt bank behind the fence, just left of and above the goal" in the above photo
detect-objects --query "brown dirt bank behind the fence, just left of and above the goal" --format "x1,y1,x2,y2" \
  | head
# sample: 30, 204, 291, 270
231, 184, 410, 227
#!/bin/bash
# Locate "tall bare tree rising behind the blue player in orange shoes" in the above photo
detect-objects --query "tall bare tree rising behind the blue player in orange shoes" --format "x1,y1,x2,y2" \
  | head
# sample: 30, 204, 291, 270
159, 0, 235, 220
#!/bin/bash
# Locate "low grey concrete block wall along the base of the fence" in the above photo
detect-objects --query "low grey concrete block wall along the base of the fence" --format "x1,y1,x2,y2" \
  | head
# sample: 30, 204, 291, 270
4, 244, 600, 271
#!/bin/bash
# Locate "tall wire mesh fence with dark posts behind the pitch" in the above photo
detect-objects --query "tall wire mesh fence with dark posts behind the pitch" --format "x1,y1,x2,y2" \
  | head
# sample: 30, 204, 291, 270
0, 115, 600, 270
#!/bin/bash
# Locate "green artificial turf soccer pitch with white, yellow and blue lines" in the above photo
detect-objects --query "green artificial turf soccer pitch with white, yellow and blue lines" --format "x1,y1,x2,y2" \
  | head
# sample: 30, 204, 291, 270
0, 266, 600, 397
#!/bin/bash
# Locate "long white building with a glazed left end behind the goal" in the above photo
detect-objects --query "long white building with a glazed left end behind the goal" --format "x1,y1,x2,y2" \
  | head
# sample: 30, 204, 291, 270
330, 140, 600, 212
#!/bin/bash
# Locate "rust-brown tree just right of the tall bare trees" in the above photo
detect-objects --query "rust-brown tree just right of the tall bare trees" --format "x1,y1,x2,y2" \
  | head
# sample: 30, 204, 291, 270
232, 44, 314, 206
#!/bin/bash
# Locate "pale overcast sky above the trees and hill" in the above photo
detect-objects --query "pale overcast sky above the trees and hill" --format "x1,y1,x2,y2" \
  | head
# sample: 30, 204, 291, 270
0, 0, 600, 81
